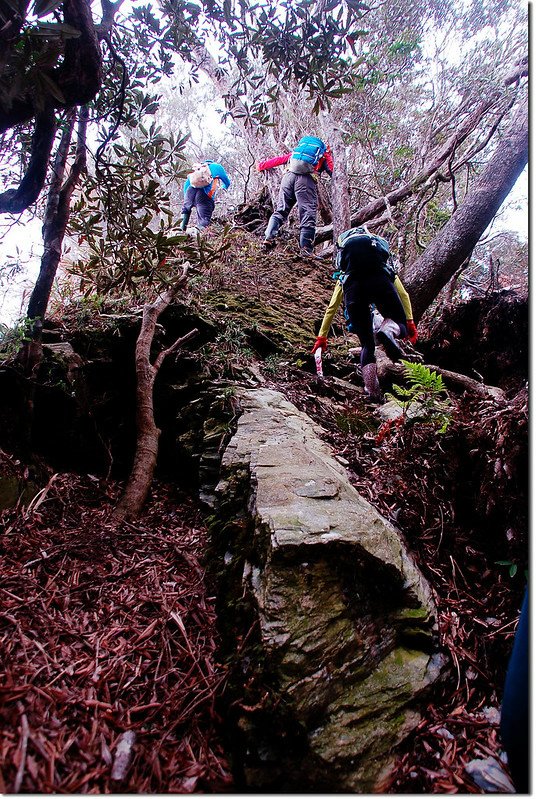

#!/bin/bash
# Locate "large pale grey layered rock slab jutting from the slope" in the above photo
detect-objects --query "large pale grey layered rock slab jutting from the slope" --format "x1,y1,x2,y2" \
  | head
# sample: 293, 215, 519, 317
213, 388, 441, 793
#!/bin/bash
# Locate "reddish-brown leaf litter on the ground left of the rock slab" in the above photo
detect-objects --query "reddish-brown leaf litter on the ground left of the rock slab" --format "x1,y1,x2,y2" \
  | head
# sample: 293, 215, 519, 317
0, 475, 231, 794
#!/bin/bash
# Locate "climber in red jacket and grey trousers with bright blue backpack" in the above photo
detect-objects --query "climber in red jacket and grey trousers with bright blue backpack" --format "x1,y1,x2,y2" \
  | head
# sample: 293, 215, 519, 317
257, 136, 333, 257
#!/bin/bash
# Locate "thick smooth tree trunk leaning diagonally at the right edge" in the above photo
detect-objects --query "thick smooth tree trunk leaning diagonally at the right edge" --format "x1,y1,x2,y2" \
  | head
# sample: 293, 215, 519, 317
404, 101, 529, 320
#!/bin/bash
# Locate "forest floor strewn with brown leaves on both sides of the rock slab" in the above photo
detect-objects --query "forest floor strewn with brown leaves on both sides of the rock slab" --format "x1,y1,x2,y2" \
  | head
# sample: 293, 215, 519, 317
0, 225, 527, 793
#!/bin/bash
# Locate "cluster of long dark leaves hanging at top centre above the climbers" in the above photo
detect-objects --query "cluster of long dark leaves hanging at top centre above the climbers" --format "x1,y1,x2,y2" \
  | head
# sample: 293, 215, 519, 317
161, 0, 367, 119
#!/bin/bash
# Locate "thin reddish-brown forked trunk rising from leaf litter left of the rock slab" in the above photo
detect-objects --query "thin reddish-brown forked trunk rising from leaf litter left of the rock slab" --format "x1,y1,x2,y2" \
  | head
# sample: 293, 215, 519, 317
113, 274, 198, 521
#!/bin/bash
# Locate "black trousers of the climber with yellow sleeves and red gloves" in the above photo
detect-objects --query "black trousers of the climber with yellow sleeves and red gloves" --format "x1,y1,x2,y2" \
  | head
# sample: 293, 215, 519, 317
343, 265, 407, 366
